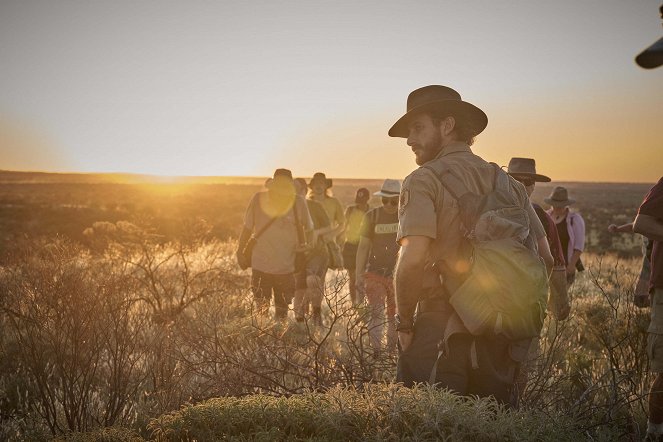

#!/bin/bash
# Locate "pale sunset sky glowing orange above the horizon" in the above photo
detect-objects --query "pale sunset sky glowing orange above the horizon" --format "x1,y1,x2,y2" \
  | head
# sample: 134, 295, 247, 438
0, 0, 663, 182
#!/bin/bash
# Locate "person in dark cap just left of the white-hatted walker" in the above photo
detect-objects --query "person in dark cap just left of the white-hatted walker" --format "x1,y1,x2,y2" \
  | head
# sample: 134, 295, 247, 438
343, 187, 371, 305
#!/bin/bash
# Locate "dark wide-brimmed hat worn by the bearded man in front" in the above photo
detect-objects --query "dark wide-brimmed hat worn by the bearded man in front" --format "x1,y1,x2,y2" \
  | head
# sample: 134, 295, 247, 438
389, 85, 488, 138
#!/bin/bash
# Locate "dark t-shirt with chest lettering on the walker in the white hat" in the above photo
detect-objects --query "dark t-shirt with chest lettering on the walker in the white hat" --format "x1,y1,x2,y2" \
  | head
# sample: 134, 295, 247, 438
361, 207, 399, 276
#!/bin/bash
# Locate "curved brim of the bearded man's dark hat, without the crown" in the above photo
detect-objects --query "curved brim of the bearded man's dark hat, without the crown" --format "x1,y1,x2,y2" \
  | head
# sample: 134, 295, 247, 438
389, 100, 488, 138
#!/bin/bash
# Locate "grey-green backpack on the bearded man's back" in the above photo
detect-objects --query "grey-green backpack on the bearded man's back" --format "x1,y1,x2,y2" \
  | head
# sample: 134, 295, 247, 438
423, 162, 548, 341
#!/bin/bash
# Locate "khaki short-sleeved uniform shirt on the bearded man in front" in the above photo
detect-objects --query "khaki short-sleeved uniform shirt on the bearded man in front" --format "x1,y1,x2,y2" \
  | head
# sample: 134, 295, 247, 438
397, 142, 545, 290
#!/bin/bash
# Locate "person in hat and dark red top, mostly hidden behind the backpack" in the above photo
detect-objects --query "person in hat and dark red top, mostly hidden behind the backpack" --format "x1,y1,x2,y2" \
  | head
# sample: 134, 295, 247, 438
507, 157, 571, 321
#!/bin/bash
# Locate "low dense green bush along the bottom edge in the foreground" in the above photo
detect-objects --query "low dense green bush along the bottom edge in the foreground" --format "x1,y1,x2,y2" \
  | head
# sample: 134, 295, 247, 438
149, 384, 587, 441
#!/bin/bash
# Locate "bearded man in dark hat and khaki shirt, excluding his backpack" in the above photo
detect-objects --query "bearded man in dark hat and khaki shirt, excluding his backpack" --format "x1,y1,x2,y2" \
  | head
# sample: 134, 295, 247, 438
389, 85, 553, 404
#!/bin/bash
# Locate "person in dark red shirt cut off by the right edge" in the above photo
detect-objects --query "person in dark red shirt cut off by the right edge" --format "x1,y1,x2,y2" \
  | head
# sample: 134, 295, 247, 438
633, 178, 663, 441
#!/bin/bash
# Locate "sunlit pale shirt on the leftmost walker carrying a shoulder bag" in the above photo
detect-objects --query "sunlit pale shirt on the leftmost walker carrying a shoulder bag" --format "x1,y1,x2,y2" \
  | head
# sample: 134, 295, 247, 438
244, 192, 313, 275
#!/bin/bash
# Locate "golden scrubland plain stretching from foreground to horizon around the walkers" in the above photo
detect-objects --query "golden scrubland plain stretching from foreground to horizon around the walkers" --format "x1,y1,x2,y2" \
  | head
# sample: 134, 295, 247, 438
0, 172, 651, 441
